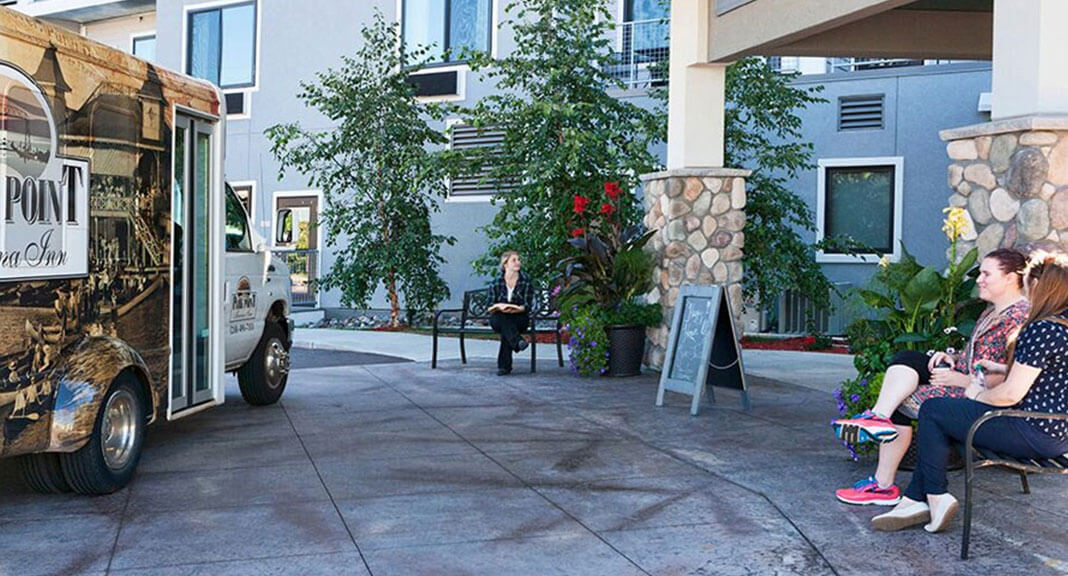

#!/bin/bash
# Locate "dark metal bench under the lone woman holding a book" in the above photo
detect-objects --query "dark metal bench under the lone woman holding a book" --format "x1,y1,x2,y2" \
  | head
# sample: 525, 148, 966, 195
430, 287, 564, 372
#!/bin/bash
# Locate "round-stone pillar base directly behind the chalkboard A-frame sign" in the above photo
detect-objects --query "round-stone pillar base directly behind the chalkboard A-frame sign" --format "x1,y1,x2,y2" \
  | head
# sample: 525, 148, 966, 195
642, 168, 750, 370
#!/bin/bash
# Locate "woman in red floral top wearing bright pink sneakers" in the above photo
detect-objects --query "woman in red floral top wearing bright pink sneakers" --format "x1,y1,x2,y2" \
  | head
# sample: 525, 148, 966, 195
834, 249, 1030, 505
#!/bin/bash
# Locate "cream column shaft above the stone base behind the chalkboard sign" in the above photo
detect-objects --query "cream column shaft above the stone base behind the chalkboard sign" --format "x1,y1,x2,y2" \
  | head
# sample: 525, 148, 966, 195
668, 0, 726, 170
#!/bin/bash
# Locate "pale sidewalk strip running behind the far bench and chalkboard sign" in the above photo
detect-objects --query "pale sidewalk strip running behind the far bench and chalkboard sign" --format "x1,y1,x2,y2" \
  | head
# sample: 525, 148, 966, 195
293, 328, 857, 393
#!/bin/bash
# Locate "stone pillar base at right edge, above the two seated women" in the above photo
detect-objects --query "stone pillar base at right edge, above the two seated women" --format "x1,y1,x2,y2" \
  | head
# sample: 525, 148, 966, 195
940, 116, 1068, 255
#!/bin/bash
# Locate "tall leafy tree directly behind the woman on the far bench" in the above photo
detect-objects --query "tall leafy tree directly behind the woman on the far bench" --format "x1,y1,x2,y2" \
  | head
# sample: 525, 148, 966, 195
465, 0, 664, 281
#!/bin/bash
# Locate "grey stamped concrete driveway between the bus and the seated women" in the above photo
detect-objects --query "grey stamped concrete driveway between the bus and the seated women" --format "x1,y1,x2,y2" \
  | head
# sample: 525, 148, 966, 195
0, 349, 1068, 576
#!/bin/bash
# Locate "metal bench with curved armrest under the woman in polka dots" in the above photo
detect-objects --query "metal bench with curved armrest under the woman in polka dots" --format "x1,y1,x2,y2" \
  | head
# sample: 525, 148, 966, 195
960, 410, 1068, 560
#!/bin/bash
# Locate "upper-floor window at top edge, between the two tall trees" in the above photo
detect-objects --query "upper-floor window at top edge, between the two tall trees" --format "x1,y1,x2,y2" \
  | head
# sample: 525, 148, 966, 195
402, 0, 493, 62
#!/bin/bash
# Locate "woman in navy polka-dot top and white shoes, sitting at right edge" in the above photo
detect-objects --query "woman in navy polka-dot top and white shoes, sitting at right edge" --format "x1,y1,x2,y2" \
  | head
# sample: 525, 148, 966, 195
871, 252, 1068, 532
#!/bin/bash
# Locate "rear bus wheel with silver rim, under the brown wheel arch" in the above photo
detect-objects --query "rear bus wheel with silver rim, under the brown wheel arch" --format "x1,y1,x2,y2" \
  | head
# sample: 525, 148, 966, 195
60, 374, 146, 495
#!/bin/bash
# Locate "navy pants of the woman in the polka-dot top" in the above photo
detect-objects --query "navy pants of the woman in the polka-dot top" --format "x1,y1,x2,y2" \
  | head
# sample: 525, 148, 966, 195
905, 398, 1068, 502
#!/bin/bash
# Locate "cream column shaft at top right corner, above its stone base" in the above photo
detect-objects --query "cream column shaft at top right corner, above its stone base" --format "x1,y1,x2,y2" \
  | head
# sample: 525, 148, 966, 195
986, 0, 1068, 120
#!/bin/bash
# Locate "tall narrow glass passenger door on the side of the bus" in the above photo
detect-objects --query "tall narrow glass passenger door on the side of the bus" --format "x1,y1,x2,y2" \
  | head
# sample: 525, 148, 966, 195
168, 112, 223, 419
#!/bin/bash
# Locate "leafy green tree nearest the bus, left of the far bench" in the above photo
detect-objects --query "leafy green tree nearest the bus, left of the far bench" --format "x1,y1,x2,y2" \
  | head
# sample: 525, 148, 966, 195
266, 11, 455, 326
